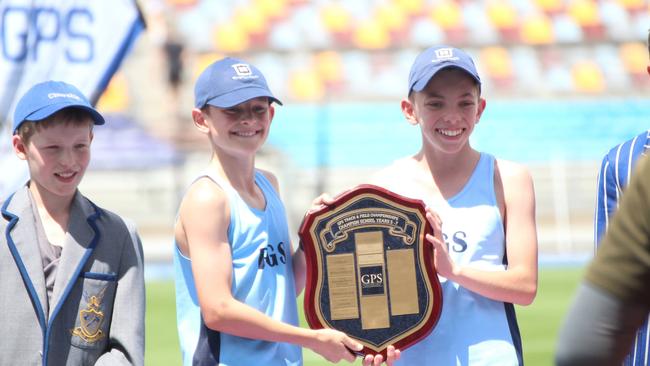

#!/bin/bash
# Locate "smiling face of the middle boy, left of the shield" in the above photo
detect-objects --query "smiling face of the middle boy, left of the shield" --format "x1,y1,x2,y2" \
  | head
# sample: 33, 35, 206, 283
192, 97, 275, 156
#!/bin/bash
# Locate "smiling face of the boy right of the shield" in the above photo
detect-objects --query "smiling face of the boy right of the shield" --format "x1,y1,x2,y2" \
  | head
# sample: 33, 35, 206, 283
402, 68, 485, 154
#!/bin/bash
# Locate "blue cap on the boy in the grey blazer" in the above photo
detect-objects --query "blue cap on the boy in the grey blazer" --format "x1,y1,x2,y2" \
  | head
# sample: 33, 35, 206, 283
13, 81, 104, 134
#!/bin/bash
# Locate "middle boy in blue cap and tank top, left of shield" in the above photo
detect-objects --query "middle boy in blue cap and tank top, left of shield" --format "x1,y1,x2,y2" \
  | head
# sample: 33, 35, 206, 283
174, 58, 370, 366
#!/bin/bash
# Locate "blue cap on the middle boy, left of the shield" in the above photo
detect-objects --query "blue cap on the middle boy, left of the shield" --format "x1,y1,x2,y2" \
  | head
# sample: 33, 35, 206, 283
194, 57, 282, 108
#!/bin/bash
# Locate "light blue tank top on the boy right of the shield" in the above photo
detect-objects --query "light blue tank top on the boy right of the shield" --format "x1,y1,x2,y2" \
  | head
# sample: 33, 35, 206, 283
392, 153, 523, 366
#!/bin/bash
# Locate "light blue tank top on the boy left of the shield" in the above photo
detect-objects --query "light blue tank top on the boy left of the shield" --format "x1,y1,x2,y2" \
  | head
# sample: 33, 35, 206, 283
174, 171, 302, 366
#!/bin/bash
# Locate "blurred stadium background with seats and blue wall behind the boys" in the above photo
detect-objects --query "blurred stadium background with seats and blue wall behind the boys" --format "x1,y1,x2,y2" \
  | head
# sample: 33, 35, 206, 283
82, 0, 650, 264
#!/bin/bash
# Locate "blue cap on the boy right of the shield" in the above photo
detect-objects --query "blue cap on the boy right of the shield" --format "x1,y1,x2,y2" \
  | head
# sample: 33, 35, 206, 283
409, 46, 481, 94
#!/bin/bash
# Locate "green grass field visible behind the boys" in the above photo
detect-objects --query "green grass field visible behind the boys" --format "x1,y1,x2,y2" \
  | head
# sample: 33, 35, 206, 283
145, 268, 582, 366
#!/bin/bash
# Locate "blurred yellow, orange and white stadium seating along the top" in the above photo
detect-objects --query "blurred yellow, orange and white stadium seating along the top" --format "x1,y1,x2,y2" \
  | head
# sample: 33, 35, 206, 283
156, 0, 650, 101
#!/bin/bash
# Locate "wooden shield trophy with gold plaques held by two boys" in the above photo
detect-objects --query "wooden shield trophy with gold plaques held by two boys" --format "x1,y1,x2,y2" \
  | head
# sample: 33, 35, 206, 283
299, 185, 442, 359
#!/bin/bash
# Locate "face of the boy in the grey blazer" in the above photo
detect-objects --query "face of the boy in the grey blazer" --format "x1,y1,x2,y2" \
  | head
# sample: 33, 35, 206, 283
12, 115, 93, 201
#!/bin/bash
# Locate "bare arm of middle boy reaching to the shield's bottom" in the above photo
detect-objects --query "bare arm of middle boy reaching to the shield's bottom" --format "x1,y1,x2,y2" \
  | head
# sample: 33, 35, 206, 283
180, 181, 362, 362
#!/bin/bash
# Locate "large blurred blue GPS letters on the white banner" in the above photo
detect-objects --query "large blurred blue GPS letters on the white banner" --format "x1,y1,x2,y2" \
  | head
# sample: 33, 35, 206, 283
0, 6, 95, 63
